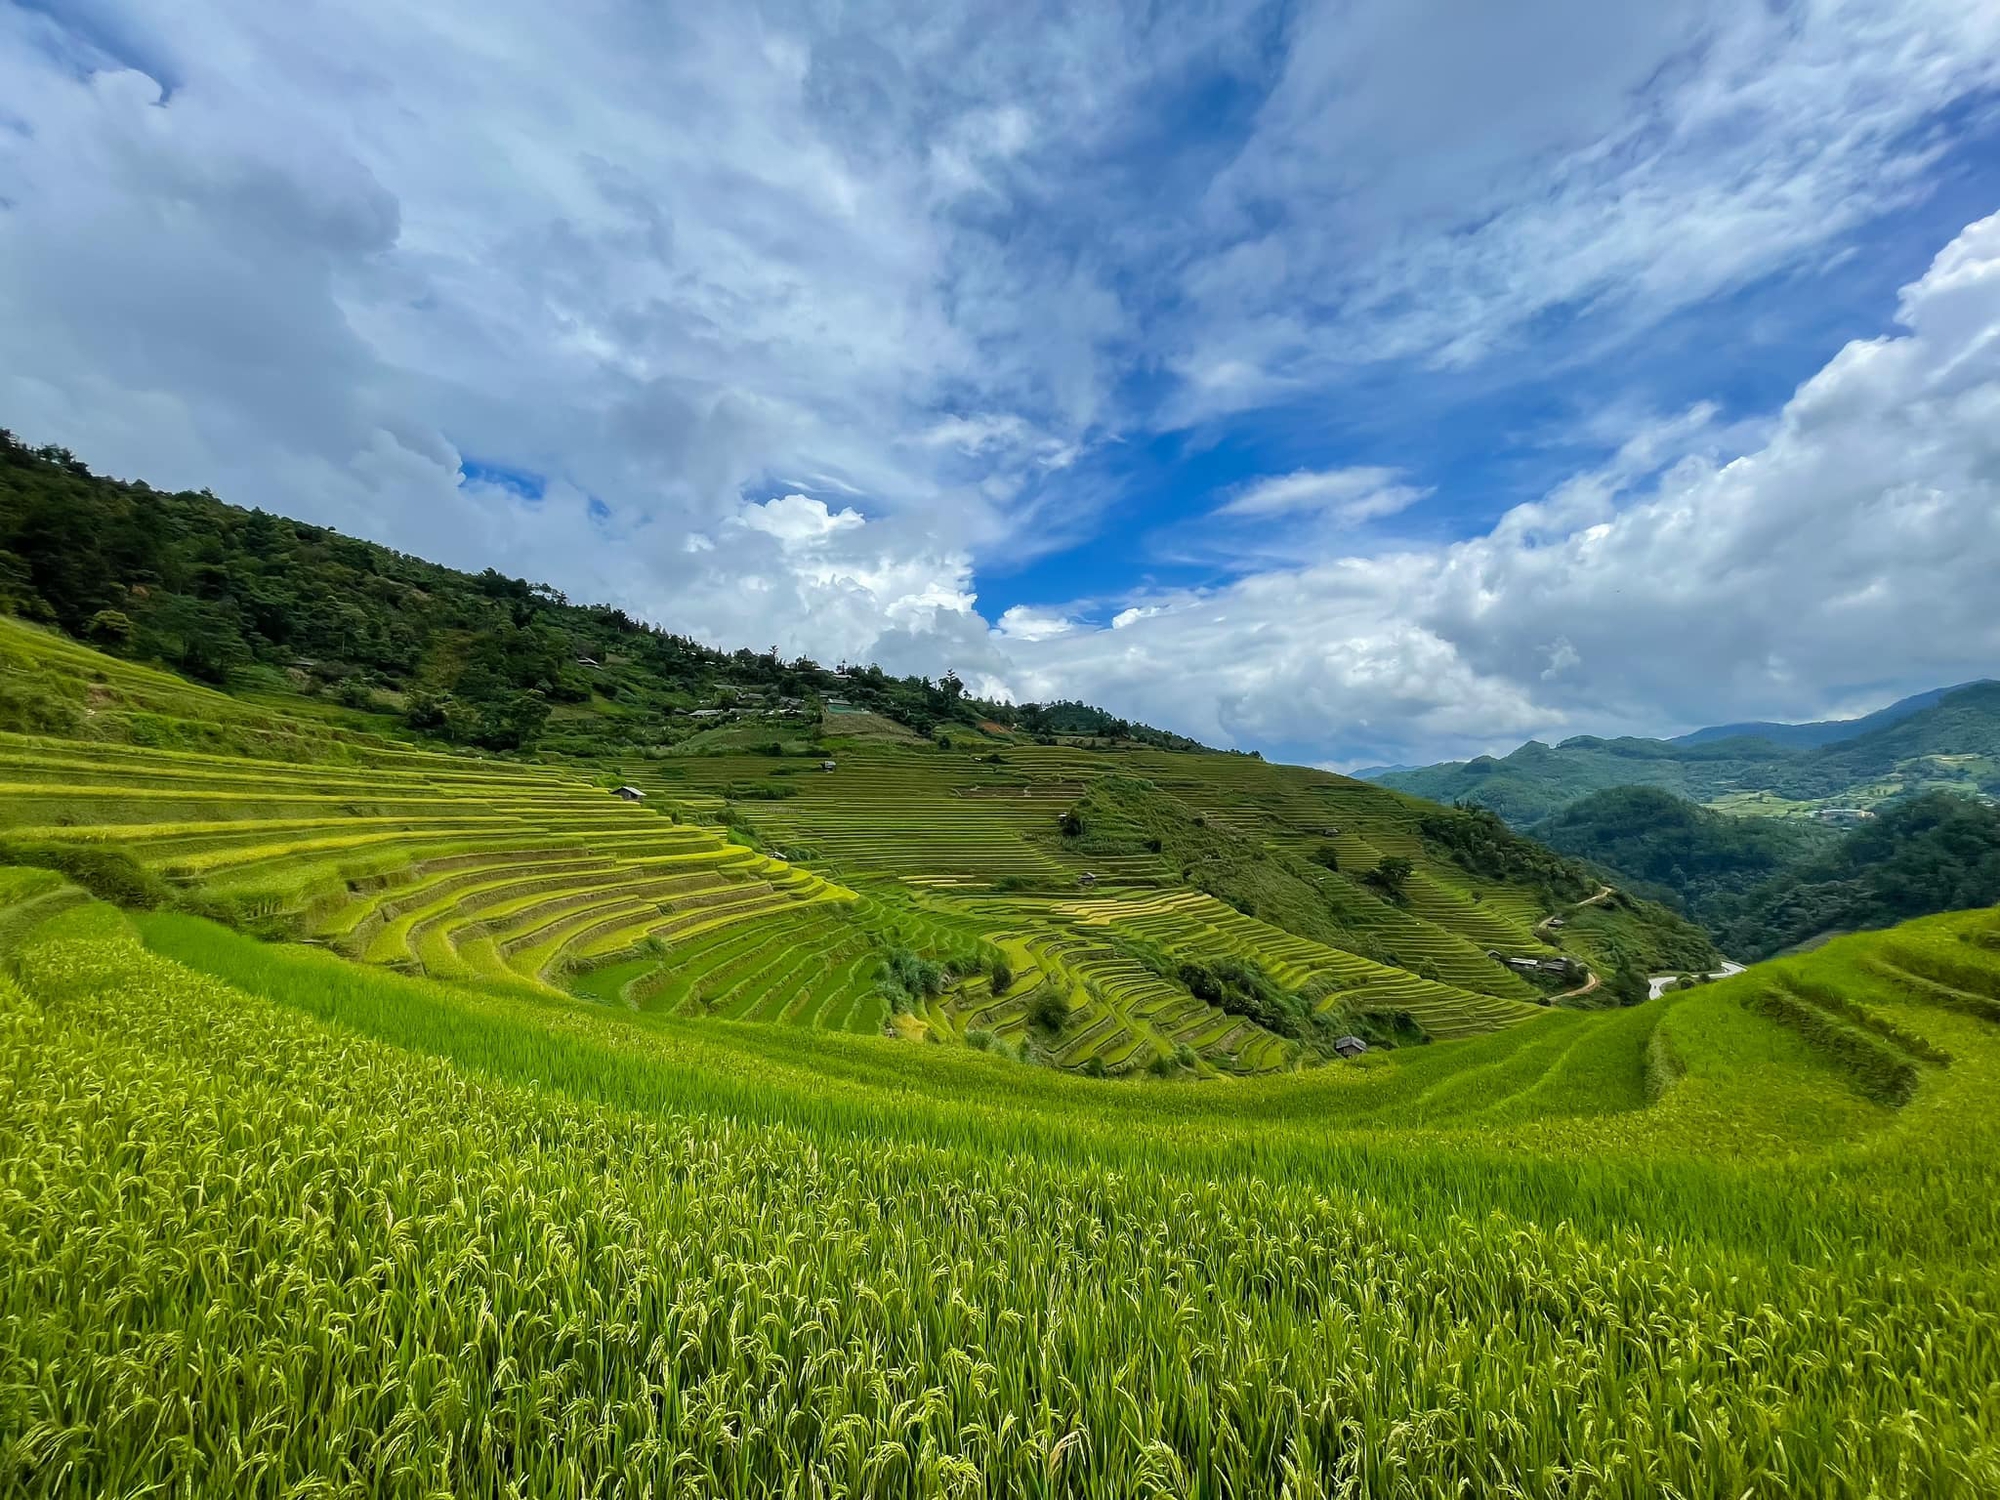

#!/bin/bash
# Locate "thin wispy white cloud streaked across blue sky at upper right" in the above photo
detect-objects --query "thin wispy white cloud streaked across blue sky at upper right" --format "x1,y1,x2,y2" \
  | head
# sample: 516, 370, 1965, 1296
1170, 0, 2000, 422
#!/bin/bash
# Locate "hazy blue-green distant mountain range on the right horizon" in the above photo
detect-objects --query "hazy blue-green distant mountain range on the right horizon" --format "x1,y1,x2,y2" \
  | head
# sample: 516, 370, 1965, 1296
1370, 682, 2000, 828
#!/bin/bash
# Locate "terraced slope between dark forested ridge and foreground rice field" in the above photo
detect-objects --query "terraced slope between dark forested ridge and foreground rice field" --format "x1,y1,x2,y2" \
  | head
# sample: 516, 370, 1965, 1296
0, 622, 1704, 1074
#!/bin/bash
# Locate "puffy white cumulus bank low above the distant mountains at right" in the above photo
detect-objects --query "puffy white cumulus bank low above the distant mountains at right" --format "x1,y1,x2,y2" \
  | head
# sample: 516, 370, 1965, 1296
992, 216, 2000, 764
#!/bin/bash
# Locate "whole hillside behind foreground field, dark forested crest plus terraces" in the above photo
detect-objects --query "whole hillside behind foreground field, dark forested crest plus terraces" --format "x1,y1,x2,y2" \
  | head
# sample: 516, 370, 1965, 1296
0, 428, 1712, 1074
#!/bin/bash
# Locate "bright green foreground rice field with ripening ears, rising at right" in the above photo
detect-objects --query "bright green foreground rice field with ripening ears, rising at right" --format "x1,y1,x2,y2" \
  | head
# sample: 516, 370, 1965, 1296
0, 888, 2000, 1496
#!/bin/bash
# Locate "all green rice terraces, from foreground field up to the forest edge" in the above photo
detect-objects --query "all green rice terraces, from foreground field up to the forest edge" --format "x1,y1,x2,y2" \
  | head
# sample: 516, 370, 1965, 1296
0, 468, 2000, 1496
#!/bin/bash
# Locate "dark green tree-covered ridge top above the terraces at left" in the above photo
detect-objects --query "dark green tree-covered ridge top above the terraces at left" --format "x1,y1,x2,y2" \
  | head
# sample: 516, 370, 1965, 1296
0, 430, 1202, 754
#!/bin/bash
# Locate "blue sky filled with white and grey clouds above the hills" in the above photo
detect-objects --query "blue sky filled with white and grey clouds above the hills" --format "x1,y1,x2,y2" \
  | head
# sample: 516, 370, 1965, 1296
0, 0, 2000, 768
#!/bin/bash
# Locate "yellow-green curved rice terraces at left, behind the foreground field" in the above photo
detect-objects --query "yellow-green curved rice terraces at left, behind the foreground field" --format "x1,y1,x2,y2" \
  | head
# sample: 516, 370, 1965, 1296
0, 736, 852, 988
